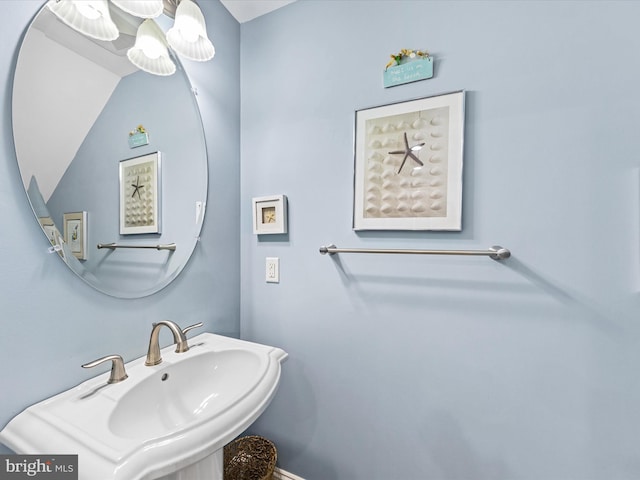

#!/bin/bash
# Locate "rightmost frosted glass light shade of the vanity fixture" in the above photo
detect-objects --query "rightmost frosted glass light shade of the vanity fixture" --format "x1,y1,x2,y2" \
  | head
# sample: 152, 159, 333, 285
167, 0, 216, 62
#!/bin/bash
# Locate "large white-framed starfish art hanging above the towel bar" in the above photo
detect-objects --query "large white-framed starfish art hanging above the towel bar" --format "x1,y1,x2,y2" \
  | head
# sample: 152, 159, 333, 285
353, 91, 464, 231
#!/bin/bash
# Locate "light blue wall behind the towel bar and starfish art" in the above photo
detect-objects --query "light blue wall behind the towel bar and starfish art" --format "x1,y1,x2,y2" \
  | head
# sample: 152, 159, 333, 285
241, 0, 640, 480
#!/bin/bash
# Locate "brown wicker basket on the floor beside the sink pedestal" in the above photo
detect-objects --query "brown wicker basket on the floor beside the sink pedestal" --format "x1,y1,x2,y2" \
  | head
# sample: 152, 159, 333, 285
224, 435, 278, 480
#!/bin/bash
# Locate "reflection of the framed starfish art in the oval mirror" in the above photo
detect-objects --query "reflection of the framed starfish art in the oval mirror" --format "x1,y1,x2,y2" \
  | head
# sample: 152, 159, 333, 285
120, 152, 162, 235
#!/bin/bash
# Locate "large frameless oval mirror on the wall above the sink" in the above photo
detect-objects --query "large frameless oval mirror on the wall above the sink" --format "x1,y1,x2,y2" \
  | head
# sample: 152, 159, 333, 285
12, 6, 208, 298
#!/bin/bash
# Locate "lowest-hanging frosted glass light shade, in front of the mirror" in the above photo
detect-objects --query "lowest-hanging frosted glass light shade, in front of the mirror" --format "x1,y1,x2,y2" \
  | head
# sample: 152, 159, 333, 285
127, 18, 176, 76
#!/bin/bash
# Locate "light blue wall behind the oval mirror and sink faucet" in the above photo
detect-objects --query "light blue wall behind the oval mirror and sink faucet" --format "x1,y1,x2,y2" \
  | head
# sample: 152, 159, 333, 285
0, 0, 240, 451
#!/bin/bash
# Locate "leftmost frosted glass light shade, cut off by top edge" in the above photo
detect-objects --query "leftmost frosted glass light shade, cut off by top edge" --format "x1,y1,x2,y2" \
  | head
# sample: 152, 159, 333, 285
47, 0, 120, 41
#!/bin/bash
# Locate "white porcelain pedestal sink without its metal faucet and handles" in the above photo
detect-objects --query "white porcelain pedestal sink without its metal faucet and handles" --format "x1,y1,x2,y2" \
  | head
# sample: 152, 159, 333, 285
0, 333, 287, 480
